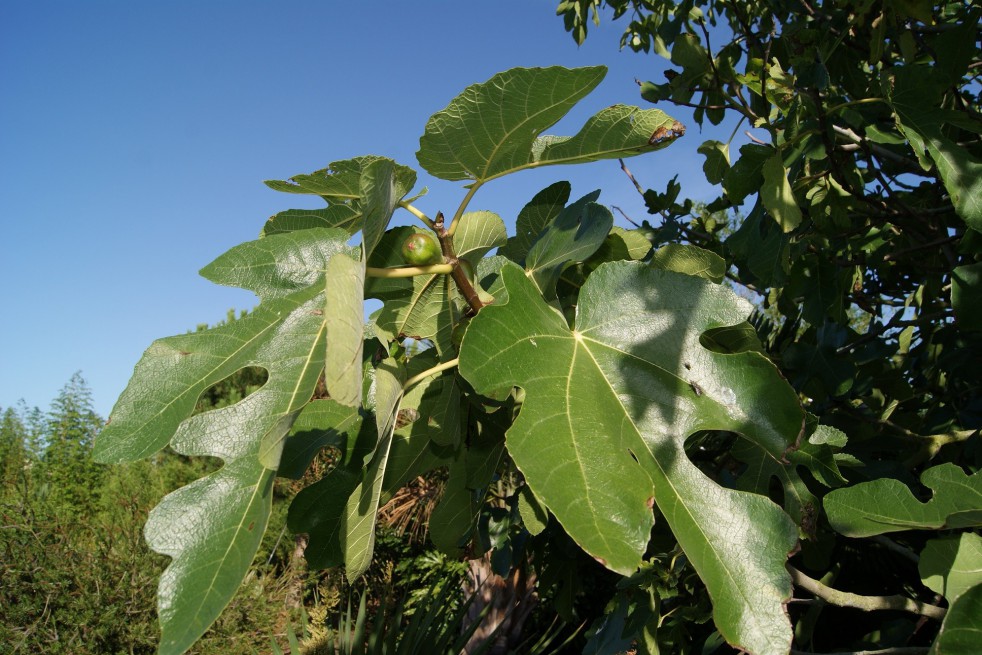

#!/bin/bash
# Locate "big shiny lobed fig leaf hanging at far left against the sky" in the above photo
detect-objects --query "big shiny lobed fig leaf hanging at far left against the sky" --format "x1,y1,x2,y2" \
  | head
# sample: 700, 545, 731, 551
95, 228, 362, 653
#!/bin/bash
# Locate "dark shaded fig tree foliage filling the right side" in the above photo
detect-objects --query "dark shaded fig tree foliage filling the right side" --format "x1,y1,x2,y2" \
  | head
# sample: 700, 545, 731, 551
558, 0, 982, 652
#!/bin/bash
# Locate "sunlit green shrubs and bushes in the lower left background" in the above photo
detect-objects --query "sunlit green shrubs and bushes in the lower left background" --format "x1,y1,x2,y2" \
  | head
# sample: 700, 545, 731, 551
0, 364, 463, 655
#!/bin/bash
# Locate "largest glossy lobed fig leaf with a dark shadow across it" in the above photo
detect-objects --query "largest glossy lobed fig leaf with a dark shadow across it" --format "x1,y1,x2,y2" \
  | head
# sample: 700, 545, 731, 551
460, 262, 803, 655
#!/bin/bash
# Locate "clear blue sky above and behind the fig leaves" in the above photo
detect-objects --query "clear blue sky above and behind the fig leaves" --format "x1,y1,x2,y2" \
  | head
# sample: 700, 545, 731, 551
0, 0, 729, 417
